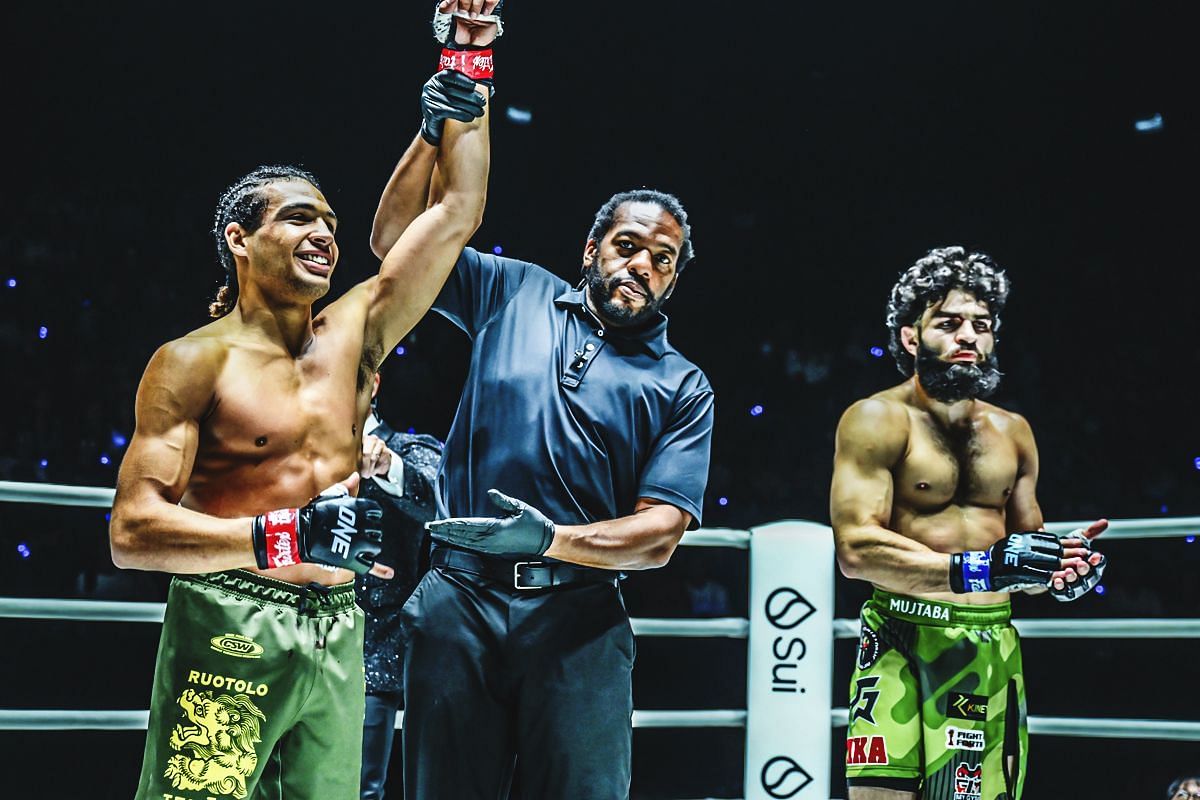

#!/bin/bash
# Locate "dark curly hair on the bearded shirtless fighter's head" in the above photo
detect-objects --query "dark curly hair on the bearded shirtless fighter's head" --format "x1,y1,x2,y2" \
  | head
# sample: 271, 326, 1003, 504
887, 247, 1008, 377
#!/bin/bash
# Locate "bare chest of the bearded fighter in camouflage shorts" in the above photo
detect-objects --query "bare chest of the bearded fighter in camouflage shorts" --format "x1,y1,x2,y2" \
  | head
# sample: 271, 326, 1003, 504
894, 420, 1020, 510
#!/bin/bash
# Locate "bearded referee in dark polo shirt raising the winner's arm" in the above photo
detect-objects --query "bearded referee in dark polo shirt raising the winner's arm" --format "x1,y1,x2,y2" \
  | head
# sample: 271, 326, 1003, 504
373, 176, 713, 800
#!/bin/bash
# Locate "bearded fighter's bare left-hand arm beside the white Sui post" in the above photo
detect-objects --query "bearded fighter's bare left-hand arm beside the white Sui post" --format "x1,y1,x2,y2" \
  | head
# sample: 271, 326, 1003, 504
829, 399, 950, 594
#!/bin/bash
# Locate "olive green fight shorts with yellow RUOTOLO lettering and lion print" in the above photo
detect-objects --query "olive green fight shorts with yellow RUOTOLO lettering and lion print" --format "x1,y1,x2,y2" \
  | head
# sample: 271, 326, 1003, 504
137, 570, 366, 800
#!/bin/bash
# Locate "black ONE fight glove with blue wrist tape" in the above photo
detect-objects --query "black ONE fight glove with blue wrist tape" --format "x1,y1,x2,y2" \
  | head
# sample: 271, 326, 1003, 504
950, 530, 1062, 593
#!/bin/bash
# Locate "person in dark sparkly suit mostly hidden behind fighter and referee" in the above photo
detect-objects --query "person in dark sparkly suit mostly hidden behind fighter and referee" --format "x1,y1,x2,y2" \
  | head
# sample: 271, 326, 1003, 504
354, 373, 442, 800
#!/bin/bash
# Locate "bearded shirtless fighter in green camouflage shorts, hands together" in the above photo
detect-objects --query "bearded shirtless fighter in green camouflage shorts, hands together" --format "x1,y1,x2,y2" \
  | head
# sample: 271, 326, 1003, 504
830, 247, 1108, 800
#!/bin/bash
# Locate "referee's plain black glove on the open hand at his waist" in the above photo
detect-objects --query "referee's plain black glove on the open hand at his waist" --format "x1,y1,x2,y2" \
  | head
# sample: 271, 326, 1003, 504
425, 489, 554, 555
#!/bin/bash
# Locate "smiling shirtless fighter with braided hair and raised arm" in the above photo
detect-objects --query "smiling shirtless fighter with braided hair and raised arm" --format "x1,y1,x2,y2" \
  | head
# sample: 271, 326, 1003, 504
110, 0, 494, 800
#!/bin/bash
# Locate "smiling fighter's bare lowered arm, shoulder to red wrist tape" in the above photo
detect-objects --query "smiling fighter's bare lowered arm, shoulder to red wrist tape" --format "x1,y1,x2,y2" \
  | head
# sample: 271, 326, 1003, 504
108, 339, 254, 573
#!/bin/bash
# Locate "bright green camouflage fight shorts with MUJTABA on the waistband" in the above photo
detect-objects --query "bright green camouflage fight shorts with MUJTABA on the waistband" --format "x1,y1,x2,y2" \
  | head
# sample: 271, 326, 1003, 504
846, 589, 1028, 800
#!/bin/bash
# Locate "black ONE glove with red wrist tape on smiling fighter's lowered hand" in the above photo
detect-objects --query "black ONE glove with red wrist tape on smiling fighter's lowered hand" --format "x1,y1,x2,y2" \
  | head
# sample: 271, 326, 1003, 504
252, 493, 383, 575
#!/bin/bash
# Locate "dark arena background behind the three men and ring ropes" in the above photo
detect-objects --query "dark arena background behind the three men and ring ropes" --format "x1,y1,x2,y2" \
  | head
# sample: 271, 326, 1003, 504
0, 0, 1200, 800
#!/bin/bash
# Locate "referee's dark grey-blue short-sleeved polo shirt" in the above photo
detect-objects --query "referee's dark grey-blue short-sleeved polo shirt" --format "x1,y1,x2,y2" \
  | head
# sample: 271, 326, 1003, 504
433, 248, 713, 528
